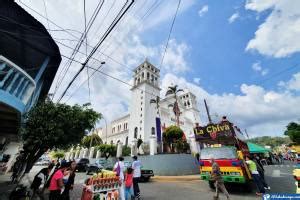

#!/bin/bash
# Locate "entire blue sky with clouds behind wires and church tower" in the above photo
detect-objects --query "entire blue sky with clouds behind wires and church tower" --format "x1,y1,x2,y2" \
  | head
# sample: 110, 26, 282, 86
20, 0, 300, 137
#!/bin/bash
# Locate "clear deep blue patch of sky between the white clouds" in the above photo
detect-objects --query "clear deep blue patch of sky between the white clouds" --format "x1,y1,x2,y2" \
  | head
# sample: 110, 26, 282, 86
143, 1, 300, 94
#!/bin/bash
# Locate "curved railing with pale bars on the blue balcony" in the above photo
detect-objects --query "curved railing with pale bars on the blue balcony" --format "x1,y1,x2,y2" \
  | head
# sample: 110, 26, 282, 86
0, 55, 36, 106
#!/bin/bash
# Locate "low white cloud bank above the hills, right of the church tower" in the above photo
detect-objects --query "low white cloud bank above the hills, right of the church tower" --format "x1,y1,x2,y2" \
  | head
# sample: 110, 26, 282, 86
162, 74, 300, 137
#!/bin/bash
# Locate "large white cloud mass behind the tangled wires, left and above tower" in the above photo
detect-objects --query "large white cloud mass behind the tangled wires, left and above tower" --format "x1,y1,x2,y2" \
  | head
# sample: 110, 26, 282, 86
17, 0, 195, 121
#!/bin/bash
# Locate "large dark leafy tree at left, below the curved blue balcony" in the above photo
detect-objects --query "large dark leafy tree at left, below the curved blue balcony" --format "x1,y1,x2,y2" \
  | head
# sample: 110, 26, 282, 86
20, 99, 101, 177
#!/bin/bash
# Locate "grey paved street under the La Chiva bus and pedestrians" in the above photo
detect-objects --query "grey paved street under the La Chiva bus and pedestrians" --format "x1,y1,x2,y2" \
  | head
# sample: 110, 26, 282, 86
67, 164, 295, 200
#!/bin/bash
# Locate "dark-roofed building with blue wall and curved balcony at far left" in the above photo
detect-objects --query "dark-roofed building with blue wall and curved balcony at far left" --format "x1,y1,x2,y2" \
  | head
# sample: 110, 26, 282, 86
0, 0, 61, 164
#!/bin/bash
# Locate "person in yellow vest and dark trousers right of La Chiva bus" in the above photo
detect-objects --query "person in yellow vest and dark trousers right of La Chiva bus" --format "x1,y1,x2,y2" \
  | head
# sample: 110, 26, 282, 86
246, 156, 266, 196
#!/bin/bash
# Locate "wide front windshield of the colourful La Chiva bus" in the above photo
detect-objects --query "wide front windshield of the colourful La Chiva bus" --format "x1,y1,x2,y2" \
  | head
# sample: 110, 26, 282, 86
200, 147, 237, 159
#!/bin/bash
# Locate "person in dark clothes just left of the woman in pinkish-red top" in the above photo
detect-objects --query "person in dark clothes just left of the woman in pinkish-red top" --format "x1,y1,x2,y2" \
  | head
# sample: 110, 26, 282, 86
30, 163, 54, 199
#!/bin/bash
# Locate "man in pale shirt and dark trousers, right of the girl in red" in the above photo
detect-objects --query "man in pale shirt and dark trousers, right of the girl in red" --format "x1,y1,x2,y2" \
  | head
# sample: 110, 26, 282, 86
132, 156, 142, 199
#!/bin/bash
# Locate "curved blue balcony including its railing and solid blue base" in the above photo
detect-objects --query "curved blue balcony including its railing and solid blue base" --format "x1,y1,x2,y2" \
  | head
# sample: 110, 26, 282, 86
0, 55, 36, 113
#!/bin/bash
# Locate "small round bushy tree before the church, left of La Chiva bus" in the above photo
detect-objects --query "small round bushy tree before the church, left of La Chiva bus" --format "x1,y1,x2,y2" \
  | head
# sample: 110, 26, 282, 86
163, 125, 184, 151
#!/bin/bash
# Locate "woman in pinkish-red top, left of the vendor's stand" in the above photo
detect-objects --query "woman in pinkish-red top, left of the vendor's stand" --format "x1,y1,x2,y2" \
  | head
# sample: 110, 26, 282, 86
48, 163, 69, 200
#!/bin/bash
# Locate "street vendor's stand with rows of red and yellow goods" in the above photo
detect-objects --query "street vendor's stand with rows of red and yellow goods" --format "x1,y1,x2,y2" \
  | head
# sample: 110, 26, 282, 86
81, 170, 122, 200
